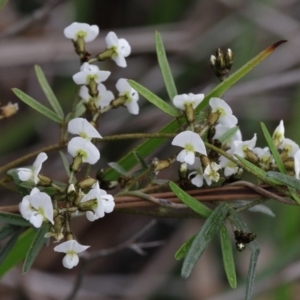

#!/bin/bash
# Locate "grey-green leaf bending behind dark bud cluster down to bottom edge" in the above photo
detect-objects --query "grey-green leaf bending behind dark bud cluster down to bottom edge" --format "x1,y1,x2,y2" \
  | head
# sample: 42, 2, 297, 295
230, 209, 260, 300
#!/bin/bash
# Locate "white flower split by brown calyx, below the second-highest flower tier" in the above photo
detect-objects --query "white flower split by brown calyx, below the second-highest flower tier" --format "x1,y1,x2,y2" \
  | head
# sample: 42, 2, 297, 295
79, 83, 115, 109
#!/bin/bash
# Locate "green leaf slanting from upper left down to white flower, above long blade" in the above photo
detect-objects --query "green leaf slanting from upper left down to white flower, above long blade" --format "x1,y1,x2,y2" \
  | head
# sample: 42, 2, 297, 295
128, 80, 179, 117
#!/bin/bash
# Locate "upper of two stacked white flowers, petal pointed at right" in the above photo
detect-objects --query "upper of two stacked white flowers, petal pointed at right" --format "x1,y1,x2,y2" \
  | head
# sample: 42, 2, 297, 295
68, 118, 102, 141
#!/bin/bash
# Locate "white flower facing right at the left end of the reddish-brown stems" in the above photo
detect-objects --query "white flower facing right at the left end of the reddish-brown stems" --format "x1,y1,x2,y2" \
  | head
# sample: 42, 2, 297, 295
81, 182, 115, 221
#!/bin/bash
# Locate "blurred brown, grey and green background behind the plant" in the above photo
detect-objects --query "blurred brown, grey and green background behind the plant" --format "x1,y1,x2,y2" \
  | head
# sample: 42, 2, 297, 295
0, 0, 300, 300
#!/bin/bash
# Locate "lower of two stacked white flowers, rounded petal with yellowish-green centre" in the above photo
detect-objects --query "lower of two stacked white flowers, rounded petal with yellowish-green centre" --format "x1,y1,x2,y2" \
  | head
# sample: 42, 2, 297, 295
68, 137, 100, 165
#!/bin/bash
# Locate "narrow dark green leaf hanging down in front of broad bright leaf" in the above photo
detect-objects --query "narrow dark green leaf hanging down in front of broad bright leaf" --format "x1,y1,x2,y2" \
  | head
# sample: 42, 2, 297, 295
23, 225, 49, 273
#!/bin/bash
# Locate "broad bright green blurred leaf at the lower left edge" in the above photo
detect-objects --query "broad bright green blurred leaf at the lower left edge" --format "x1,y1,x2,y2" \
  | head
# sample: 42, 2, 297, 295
0, 228, 35, 278
